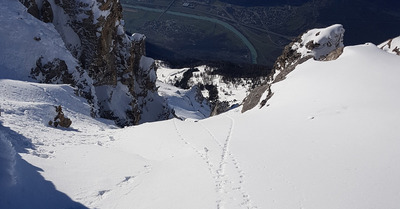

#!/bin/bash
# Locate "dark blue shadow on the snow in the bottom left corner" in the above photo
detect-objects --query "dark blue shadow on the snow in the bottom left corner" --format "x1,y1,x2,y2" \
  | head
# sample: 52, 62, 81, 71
0, 121, 87, 209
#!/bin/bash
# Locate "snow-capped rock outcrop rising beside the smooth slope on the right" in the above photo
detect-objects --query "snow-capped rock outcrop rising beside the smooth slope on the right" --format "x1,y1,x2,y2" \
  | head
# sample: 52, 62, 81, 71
242, 24, 344, 112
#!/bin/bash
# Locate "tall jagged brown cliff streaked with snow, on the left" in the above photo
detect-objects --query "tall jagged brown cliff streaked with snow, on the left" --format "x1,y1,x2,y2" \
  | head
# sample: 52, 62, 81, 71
20, 0, 171, 126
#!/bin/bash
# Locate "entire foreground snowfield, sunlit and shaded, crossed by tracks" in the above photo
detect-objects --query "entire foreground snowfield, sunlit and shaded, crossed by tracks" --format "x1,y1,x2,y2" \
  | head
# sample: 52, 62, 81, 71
0, 41, 400, 209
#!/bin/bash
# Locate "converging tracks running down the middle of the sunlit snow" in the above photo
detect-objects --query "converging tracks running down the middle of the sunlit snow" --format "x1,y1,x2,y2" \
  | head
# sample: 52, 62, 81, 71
173, 116, 257, 209
